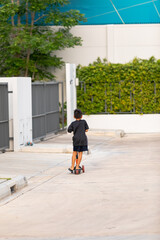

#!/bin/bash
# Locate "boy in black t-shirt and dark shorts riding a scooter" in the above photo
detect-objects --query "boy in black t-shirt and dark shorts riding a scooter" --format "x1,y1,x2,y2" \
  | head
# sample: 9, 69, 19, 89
68, 109, 89, 173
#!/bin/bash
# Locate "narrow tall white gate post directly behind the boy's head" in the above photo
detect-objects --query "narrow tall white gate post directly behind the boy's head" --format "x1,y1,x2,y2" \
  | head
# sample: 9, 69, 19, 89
66, 63, 77, 127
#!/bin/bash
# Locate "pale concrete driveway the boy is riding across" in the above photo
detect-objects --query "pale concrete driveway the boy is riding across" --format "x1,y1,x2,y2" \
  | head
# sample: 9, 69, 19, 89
0, 134, 160, 240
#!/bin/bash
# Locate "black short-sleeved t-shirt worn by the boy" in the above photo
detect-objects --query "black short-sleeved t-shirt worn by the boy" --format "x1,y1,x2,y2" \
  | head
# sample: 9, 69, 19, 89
68, 120, 89, 146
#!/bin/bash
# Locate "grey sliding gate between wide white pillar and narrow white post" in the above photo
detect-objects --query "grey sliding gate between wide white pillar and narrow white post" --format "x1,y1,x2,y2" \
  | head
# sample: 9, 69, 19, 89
32, 82, 64, 139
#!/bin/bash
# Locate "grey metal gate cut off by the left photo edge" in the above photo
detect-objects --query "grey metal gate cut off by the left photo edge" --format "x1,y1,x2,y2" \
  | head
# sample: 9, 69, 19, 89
0, 83, 9, 150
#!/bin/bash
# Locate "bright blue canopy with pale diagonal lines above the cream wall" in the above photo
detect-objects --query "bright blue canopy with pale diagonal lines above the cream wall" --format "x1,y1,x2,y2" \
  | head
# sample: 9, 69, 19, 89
64, 0, 160, 25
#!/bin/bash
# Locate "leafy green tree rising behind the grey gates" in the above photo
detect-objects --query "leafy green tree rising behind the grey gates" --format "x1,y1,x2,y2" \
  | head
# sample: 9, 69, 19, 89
0, 0, 85, 80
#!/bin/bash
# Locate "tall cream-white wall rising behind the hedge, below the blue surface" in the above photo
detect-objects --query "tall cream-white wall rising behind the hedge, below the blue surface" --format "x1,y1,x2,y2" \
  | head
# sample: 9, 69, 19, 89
53, 24, 160, 81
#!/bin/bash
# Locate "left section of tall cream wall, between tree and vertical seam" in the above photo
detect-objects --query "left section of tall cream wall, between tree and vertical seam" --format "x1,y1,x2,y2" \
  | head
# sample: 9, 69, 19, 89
53, 26, 107, 69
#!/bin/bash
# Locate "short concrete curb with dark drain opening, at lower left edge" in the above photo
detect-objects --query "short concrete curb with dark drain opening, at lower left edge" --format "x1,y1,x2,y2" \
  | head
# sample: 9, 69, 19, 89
0, 176, 28, 200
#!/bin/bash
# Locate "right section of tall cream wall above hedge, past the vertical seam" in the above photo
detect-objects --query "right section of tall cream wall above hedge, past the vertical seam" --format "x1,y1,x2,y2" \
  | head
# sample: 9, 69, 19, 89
107, 24, 160, 63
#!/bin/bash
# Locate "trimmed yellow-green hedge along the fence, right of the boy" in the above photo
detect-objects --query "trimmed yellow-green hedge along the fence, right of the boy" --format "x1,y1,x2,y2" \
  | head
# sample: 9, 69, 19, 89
77, 57, 160, 114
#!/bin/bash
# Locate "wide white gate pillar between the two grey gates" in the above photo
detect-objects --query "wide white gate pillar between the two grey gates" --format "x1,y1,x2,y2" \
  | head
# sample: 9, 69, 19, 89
0, 77, 32, 151
